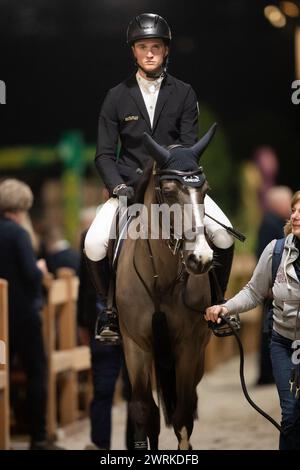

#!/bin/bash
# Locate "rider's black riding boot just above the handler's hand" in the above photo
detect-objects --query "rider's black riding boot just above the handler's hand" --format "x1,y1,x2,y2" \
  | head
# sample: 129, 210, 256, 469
214, 245, 234, 303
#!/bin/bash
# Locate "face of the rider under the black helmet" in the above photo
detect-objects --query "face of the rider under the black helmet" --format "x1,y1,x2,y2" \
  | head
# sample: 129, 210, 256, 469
132, 39, 169, 78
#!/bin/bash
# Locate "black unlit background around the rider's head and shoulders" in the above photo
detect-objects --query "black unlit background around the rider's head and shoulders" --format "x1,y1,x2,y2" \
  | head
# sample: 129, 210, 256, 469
0, 0, 300, 189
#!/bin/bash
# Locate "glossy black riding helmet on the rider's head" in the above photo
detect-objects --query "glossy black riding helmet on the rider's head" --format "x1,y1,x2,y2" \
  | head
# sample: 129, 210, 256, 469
127, 13, 172, 46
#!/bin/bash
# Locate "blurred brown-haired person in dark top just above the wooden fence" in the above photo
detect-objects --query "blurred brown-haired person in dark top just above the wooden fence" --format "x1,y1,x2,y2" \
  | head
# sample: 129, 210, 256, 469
43, 226, 80, 275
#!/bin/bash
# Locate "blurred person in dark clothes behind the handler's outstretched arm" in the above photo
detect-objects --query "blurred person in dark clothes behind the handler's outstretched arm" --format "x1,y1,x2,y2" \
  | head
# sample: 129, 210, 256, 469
256, 186, 293, 385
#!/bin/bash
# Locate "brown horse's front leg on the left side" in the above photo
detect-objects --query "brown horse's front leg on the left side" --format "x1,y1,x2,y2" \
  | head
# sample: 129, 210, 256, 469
123, 334, 160, 450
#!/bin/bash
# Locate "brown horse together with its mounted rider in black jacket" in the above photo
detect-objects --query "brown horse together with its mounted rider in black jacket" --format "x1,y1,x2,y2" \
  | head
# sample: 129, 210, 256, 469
85, 13, 234, 449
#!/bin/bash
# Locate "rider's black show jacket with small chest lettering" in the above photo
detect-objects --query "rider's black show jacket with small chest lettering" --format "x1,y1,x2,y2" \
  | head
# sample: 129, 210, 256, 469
95, 74, 198, 193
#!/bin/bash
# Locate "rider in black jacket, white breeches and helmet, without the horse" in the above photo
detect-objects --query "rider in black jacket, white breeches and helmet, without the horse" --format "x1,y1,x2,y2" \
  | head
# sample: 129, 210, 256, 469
85, 13, 234, 341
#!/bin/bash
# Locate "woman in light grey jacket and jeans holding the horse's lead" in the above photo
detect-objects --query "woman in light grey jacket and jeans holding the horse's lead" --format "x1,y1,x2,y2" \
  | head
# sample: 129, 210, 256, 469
205, 191, 300, 450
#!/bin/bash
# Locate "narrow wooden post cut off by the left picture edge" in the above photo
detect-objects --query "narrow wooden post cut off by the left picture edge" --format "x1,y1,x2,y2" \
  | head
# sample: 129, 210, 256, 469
0, 279, 9, 449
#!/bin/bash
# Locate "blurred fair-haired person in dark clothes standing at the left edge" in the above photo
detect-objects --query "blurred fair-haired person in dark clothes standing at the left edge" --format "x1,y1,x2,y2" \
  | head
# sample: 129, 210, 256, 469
0, 179, 60, 450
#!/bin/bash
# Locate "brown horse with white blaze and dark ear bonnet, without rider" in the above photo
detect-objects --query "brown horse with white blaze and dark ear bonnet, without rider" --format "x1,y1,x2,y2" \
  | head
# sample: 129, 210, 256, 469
116, 125, 215, 450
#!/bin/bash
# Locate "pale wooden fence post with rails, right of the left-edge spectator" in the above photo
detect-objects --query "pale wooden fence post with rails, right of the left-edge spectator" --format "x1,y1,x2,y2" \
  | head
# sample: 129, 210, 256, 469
44, 269, 90, 437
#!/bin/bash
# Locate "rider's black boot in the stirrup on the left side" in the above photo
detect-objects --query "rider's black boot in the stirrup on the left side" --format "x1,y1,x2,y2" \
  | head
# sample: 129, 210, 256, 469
85, 256, 120, 344
